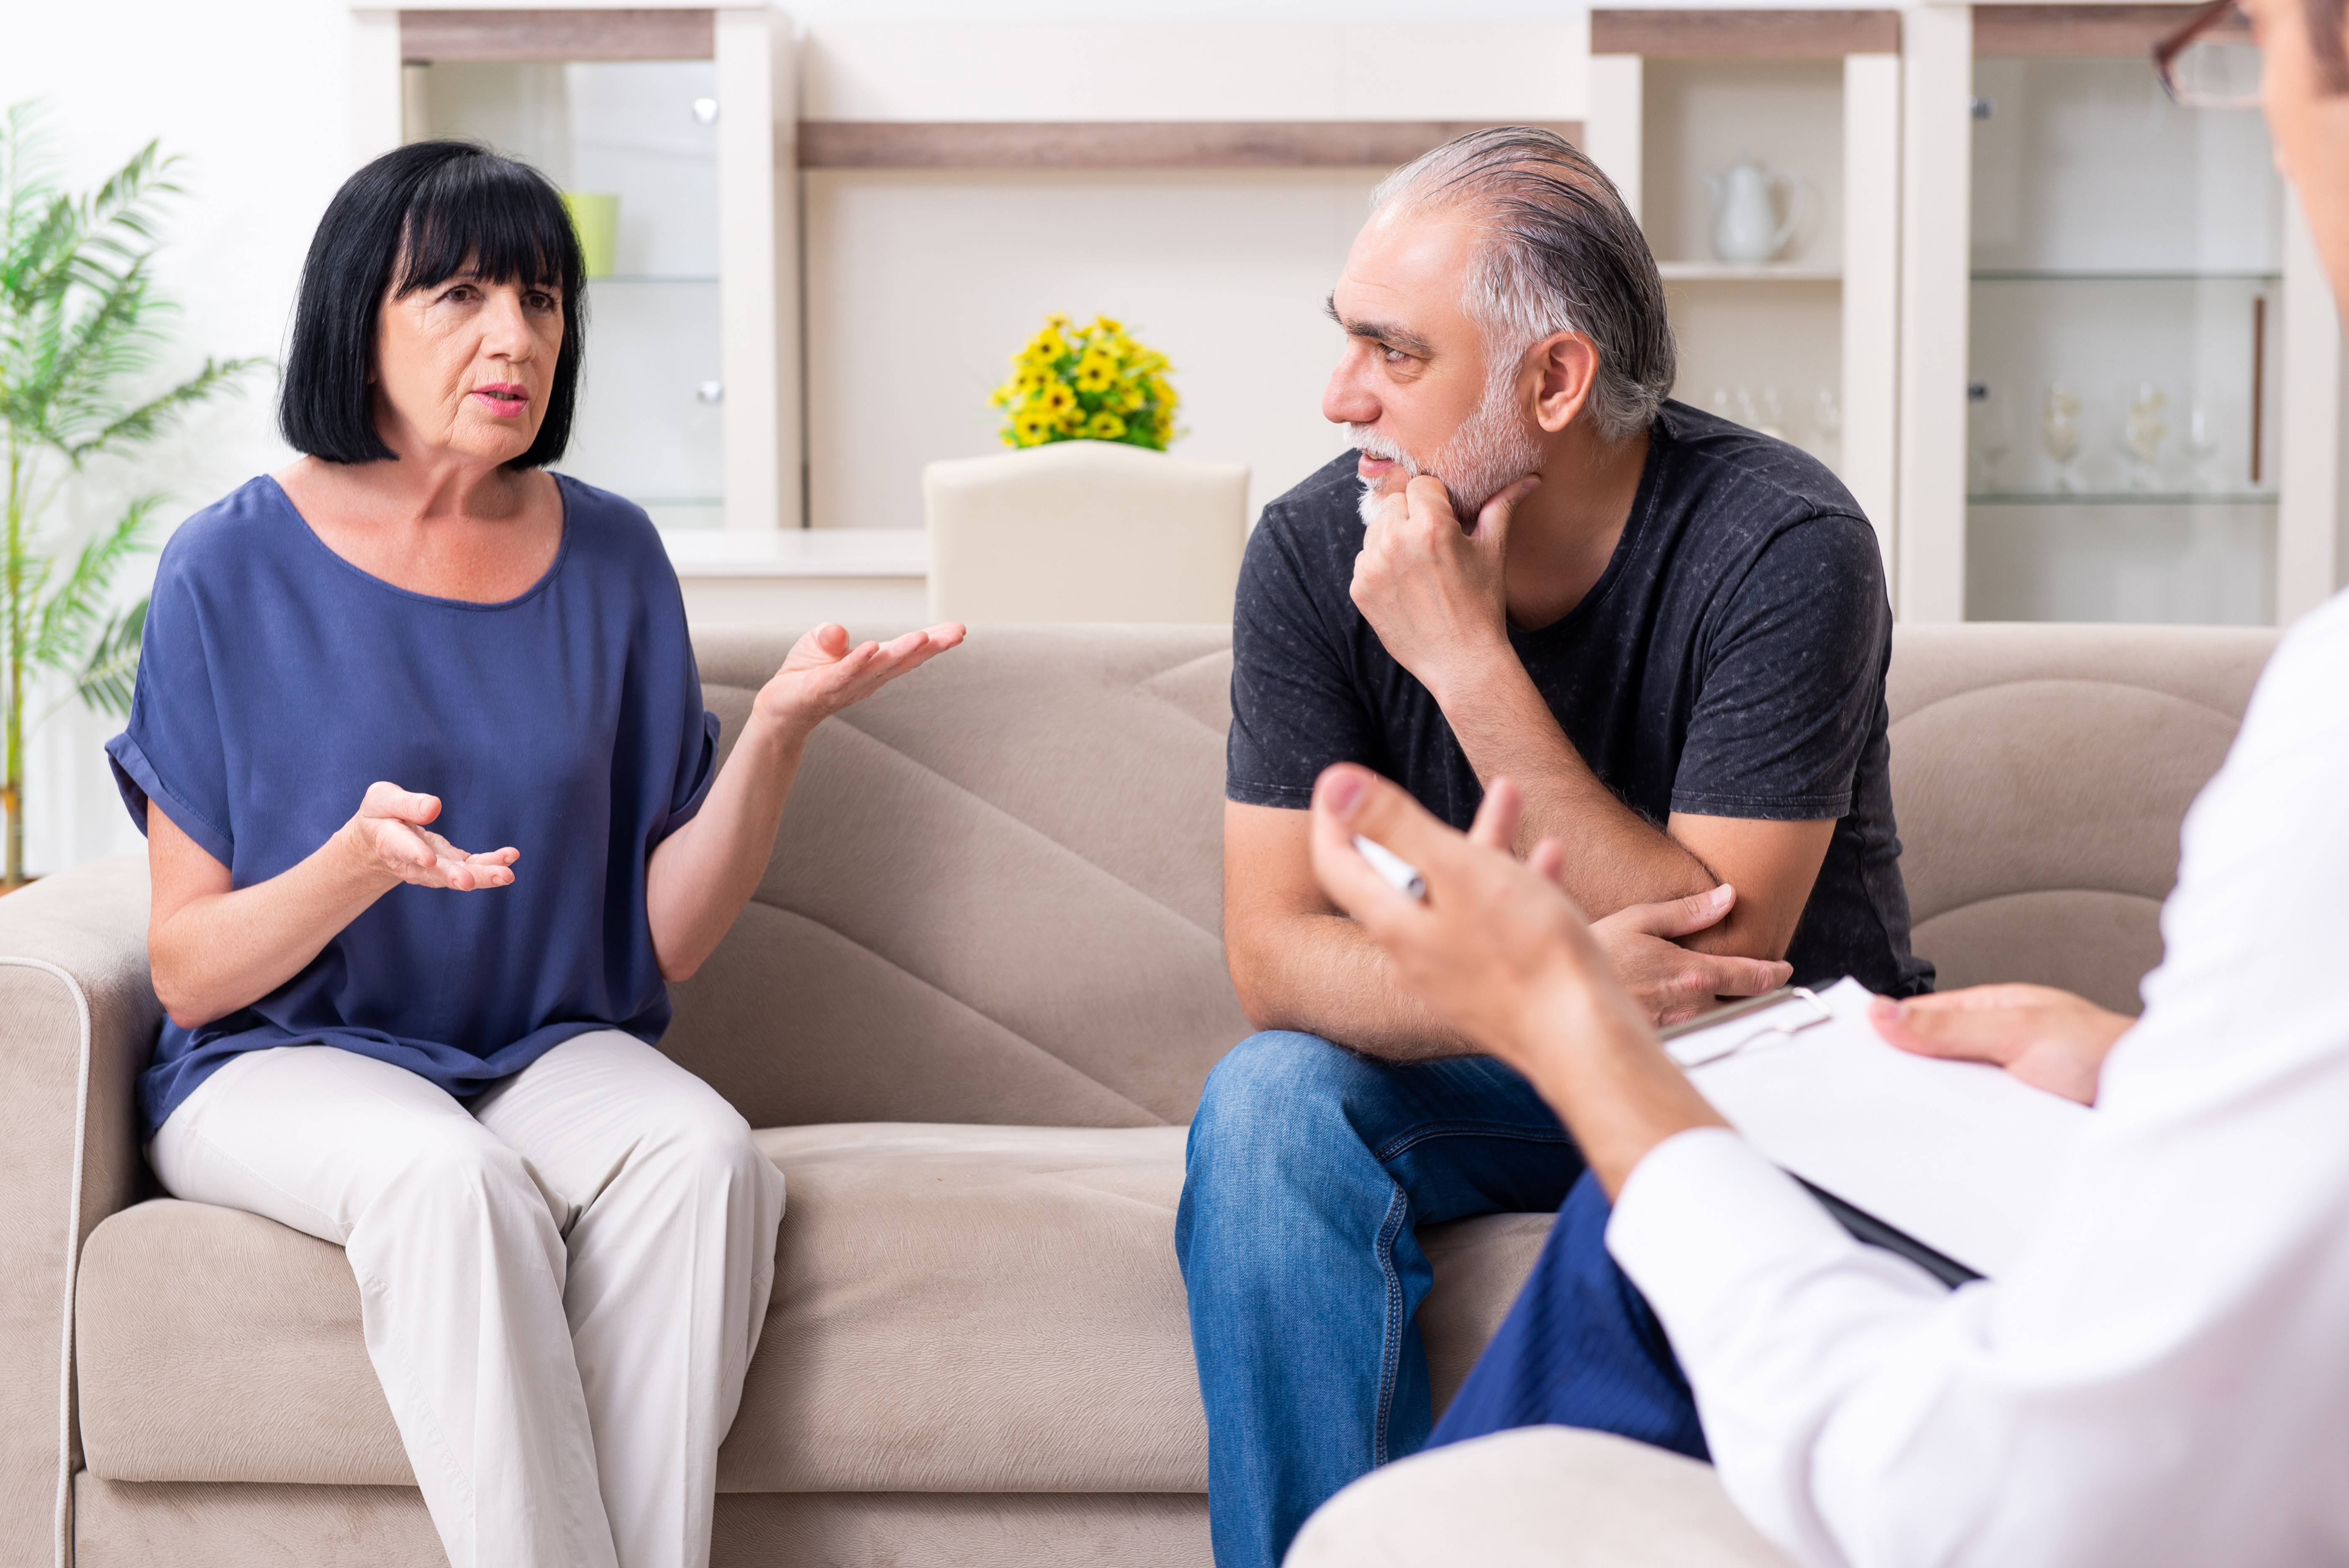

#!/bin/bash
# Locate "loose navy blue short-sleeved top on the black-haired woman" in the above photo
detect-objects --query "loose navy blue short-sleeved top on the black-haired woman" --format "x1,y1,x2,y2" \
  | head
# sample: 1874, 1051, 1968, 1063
106, 477, 719, 1139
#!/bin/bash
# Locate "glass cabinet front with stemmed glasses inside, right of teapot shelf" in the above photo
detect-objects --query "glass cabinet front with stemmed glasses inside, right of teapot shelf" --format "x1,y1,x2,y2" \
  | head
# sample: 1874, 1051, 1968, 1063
1964, 51, 2285, 624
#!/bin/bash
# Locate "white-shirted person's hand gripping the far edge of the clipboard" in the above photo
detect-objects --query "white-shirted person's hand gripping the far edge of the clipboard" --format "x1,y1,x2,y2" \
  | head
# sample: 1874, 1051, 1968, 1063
1867, 986, 2135, 1106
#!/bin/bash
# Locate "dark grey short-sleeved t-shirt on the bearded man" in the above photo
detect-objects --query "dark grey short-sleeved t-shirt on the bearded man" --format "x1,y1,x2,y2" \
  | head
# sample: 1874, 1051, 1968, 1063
1224, 404, 1933, 995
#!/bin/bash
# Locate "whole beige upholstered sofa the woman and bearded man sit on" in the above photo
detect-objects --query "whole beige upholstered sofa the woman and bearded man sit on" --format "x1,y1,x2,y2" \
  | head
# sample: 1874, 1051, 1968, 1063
0, 627, 2272, 1568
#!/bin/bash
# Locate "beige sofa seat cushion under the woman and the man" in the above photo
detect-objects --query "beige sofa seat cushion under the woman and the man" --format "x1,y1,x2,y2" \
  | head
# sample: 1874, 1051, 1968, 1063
77, 1124, 1548, 1493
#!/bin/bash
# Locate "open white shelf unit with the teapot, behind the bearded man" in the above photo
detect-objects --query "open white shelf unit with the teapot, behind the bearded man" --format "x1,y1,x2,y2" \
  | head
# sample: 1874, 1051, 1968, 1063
1586, 9, 1900, 570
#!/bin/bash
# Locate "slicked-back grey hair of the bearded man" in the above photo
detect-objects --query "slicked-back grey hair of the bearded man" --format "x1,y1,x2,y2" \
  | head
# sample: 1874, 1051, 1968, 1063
1369, 124, 1677, 441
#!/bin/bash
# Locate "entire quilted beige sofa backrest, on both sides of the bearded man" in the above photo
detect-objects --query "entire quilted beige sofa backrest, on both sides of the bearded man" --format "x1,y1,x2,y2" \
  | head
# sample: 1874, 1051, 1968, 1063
665, 624, 2274, 1127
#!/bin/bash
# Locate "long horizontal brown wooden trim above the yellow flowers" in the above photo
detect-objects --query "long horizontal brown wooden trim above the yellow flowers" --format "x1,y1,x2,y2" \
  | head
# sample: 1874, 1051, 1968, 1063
798, 120, 1583, 169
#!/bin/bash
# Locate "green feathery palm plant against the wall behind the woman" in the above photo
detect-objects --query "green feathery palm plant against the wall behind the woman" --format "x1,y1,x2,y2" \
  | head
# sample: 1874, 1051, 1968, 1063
0, 103, 261, 887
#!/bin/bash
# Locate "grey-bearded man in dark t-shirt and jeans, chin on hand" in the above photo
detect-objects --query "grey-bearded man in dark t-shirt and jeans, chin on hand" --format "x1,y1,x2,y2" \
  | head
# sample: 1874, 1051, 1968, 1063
1177, 127, 1931, 1568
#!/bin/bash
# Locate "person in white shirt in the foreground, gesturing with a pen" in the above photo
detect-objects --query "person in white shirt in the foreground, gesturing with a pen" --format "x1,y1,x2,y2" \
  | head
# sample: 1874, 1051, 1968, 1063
1290, 0, 2349, 1568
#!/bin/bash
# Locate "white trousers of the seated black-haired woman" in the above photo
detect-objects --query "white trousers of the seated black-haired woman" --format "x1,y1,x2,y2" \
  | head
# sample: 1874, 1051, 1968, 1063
148, 1030, 782, 1568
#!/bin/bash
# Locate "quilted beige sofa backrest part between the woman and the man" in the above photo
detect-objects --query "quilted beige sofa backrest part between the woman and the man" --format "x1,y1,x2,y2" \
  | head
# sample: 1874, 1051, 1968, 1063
662, 627, 1248, 1127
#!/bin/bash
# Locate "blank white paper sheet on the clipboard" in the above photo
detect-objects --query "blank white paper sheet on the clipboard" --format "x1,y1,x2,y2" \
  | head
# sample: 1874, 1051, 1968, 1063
1666, 979, 2095, 1279
